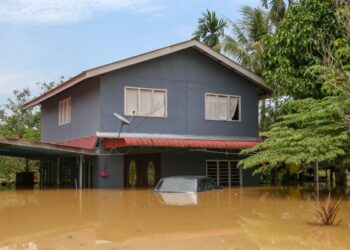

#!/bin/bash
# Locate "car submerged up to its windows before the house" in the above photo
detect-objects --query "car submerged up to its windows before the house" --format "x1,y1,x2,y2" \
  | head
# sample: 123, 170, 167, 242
154, 176, 220, 193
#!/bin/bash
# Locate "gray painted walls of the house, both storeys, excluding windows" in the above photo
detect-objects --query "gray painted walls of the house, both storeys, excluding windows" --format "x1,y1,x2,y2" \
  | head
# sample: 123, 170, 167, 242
41, 48, 258, 188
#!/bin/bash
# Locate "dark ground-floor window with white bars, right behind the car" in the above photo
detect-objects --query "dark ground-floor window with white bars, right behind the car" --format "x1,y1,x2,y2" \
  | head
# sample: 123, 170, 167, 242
206, 160, 242, 187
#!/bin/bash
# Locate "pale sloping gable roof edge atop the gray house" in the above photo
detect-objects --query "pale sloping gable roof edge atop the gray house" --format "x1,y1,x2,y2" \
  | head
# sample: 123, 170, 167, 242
22, 39, 272, 109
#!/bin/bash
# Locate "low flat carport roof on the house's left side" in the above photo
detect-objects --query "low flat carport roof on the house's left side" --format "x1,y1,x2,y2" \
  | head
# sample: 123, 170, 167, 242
0, 137, 95, 159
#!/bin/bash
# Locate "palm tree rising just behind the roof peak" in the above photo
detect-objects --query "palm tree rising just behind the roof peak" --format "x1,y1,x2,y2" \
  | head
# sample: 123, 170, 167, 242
193, 10, 226, 51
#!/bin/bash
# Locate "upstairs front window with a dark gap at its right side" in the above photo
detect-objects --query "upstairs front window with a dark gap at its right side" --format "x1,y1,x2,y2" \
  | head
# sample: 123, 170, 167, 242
205, 93, 241, 121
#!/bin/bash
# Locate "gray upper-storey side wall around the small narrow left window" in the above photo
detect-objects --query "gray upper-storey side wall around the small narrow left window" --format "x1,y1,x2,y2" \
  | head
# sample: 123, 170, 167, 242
41, 78, 100, 142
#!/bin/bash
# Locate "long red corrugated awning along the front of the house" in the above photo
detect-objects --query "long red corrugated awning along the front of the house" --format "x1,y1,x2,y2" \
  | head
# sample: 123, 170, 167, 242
103, 138, 261, 149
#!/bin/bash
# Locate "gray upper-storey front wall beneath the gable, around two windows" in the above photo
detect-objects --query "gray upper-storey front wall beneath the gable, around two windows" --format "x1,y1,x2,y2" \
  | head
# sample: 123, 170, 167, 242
101, 49, 258, 137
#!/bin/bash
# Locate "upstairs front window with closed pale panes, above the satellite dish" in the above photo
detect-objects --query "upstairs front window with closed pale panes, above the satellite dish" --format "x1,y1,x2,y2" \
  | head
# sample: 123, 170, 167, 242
124, 87, 167, 117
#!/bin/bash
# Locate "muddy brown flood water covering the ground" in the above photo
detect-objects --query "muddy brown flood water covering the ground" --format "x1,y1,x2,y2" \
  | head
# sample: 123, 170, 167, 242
0, 188, 350, 250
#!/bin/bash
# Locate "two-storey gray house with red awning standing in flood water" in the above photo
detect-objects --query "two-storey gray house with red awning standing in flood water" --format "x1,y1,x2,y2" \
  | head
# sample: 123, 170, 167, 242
23, 40, 271, 188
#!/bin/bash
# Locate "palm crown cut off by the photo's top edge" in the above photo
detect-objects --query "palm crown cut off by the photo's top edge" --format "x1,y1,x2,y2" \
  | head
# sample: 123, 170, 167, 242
261, 0, 296, 25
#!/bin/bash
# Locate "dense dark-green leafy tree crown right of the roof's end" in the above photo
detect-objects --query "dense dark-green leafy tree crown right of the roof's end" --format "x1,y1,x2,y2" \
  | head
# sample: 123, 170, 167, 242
261, 0, 344, 99
